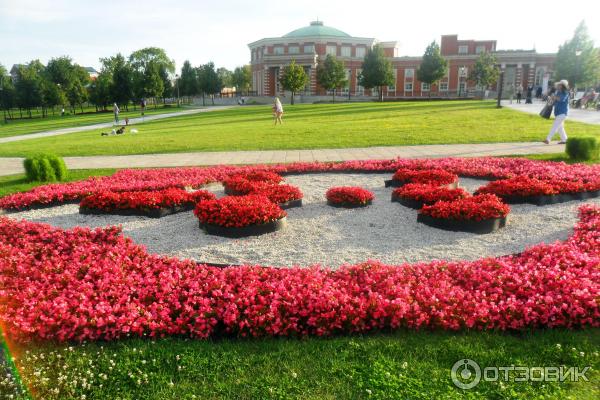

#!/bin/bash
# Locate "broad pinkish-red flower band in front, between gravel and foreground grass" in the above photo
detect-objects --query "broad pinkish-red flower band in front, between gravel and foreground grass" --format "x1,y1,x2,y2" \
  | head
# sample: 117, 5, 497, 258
0, 206, 600, 341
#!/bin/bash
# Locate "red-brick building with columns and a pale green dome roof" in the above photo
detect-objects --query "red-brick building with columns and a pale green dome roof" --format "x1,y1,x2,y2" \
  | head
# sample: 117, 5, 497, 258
248, 21, 556, 98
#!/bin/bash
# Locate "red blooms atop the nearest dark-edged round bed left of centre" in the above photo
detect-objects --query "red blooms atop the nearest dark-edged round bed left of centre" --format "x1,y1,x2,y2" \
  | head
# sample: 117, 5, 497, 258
194, 195, 287, 228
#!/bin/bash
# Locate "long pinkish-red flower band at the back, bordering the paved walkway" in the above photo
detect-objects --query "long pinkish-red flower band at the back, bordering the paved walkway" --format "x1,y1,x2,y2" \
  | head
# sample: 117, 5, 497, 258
0, 157, 600, 210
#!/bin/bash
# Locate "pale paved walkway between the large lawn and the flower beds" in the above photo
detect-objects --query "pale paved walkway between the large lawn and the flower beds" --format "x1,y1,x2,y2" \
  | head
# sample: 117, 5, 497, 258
0, 142, 565, 175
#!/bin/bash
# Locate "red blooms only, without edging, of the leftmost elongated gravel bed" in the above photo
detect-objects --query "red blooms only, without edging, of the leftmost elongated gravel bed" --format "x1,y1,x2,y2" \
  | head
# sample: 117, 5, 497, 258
80, 188, 216, 212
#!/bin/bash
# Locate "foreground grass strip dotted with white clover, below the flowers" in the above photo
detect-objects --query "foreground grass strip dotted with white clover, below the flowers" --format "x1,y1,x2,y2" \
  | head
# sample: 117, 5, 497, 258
4, 329, 600, 400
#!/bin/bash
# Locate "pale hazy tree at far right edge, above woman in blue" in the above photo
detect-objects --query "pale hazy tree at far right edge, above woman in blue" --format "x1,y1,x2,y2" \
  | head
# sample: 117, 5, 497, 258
554, 21, 600, 87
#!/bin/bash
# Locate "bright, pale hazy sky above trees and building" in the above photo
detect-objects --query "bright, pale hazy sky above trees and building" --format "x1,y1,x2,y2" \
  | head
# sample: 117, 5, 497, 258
0, 0, 600, 70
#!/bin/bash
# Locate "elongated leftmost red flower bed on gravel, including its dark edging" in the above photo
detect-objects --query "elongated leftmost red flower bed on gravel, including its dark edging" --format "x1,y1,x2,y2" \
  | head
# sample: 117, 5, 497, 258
79, 188, 216, 218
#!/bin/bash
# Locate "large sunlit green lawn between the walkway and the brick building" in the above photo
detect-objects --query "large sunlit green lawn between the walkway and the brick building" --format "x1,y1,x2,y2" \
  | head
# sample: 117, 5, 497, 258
0, 101, 600, 156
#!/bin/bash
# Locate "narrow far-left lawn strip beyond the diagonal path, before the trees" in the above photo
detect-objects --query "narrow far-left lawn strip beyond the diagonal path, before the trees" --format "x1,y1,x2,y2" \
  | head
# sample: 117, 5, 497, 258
0, 107, 192, 138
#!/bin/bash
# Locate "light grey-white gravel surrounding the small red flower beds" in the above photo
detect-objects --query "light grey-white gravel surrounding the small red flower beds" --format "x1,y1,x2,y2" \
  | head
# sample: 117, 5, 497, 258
9, 174, 600, 267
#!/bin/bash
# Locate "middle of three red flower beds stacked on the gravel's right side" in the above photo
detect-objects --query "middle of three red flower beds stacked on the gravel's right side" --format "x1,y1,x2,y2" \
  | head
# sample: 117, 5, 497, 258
392, 183, 469, 209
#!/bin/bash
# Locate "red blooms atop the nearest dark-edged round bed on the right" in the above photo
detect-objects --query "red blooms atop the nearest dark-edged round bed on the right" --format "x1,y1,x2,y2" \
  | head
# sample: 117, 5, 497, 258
419, 194, 510, 221
